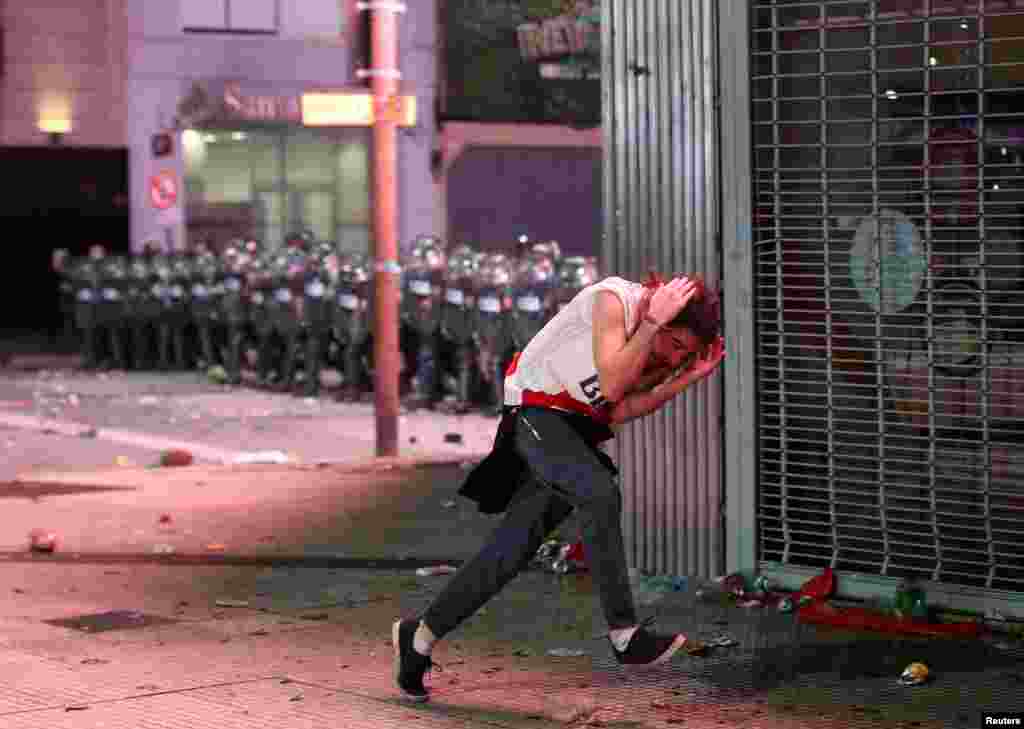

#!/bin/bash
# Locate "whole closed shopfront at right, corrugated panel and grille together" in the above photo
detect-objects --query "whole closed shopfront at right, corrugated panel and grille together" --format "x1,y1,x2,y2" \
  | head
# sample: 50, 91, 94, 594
602, 0, 1024, 612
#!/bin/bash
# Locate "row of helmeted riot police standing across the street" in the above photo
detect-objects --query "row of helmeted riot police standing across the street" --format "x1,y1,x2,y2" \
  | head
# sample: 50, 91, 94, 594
53, 234, 598, 412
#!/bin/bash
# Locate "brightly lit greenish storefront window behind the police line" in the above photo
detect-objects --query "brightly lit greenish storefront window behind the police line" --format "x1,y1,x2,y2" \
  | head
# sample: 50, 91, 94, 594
183, 129, 371, 253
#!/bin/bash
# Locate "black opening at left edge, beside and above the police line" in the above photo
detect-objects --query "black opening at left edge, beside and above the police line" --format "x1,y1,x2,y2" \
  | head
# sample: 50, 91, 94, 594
0, 145, 131, 354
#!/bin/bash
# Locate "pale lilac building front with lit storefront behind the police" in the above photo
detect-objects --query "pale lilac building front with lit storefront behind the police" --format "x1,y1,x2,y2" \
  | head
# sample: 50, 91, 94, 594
126, 0, 435, 253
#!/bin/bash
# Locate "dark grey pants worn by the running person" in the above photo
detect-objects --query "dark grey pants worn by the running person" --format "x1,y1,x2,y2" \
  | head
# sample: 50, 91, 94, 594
423, 408, 637, 638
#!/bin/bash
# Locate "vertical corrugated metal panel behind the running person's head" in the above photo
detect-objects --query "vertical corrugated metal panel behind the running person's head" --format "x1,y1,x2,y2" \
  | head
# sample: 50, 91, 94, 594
601, 0, 725, 576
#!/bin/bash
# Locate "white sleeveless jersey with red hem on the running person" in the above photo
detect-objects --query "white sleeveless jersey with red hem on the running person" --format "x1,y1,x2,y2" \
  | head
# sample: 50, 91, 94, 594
505, 276, 643, 422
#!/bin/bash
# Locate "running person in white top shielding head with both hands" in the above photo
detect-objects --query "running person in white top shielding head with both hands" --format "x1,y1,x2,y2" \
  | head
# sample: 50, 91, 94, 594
391, 276, 725, 701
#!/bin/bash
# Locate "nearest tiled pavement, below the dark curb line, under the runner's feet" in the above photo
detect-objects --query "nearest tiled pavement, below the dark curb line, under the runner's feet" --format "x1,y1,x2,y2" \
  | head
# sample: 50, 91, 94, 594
0, 562, 1024, 729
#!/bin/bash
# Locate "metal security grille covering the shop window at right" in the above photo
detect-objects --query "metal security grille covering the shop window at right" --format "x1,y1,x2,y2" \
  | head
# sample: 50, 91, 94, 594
751, 0, 1024, 592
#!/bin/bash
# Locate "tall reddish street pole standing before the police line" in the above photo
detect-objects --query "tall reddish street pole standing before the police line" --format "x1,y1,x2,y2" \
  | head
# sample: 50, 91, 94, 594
358, 0, 406, 456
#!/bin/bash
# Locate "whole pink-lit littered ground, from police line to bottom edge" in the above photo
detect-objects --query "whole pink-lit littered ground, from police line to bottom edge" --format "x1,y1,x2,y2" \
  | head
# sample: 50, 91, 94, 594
0, 370, 1024, 729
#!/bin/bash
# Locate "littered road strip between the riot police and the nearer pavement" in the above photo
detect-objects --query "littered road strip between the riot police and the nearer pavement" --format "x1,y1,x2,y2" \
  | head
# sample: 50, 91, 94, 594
0, 371, 498, 482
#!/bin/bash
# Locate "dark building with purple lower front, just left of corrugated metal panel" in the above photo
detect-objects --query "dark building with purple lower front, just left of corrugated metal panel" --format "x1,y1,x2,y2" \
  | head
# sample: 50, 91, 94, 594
435, 0, 602, 256
